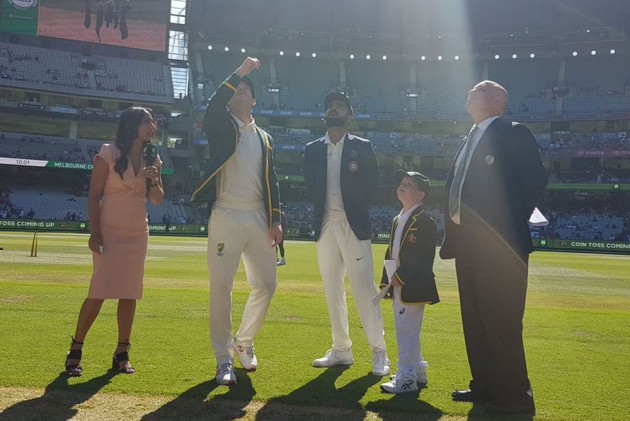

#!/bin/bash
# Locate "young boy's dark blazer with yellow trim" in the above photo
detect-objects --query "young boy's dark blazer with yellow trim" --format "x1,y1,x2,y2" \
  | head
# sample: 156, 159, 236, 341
380, 206, 440, 304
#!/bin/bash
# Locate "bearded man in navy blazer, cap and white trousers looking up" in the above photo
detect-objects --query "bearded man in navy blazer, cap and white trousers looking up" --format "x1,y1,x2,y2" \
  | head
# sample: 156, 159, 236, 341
304, 92, 389, 376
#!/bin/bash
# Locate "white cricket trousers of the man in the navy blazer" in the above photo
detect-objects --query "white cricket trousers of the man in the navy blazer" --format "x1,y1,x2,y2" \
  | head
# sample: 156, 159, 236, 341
317, 218, 386, 351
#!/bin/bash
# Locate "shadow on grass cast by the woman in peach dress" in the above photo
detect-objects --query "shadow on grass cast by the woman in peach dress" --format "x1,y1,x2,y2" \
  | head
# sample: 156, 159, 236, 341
0, 370, 117, 421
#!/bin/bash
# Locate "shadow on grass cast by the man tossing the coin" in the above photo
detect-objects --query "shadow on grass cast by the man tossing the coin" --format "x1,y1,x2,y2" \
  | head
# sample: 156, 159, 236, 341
142, 368, 256, 421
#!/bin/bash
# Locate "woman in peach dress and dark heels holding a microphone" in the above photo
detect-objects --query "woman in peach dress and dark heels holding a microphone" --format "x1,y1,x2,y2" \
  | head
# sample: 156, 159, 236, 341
66, 107, 164, 377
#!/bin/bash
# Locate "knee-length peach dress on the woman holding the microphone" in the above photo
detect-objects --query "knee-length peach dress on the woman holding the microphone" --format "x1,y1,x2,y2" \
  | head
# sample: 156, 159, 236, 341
88, 144, 162, 300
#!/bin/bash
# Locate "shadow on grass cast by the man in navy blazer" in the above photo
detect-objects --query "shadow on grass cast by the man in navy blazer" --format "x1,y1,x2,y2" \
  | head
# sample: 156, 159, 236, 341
256, 366, 381, 421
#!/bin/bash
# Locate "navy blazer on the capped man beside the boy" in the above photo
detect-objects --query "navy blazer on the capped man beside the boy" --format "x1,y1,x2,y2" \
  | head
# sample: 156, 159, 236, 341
304, 133, 380, 241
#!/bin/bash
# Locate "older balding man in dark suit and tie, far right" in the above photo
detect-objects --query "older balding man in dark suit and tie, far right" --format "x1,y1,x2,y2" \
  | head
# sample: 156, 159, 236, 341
440, 80, 547, 415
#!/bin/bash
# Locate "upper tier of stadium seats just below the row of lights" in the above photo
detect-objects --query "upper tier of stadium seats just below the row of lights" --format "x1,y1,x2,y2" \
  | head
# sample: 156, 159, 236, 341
202, 52, 630, 120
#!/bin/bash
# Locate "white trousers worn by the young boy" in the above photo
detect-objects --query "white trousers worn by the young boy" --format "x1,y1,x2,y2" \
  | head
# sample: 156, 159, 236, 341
393, 287, 428, 382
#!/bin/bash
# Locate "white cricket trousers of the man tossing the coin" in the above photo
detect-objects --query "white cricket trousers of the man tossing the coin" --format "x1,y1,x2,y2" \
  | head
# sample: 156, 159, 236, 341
208, 206, 277, 363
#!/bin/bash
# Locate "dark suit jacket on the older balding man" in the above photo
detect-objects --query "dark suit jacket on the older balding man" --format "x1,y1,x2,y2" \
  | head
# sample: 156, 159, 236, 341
440, 118, 547, 259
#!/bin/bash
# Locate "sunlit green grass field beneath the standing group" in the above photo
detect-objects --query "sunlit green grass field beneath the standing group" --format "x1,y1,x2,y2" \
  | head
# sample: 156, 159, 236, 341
0, 231, 630, 420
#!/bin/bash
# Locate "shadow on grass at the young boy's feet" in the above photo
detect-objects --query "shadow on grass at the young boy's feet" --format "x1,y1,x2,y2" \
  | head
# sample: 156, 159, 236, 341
365, 389, 443, 421
